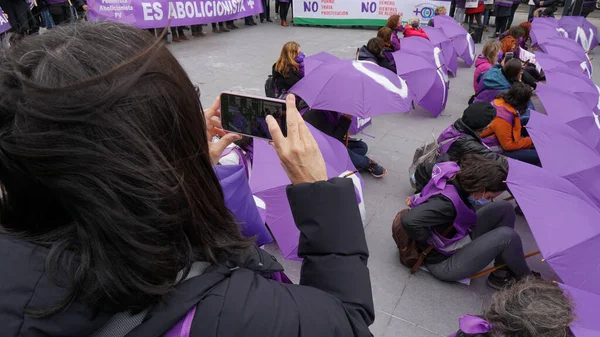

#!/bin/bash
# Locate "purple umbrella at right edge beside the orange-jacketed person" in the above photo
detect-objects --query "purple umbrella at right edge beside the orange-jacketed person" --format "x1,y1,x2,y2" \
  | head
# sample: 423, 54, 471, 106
527, 111, 600, 205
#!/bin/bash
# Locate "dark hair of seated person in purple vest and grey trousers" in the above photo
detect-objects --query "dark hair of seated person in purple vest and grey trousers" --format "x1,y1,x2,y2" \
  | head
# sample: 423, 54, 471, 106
455, 153, 508, 194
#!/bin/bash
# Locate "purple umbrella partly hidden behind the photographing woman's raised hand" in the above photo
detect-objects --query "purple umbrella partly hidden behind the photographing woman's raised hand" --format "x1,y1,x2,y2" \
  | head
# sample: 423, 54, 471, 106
250, 125, 358, 259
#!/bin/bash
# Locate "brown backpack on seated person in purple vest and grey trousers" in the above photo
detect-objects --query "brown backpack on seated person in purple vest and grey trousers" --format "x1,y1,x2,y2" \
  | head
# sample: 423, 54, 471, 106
392, 208, 454, 274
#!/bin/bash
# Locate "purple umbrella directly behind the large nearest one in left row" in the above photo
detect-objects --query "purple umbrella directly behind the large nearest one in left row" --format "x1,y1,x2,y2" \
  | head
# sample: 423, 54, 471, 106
392, 37, 449, 117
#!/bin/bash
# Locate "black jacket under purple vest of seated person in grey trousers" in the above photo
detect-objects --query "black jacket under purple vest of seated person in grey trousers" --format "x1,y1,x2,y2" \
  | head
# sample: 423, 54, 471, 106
402, 167, 472, 264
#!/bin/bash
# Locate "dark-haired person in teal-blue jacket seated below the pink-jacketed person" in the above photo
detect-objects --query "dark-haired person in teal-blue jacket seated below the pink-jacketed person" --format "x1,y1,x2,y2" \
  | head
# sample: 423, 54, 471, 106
474, 58, 523, 103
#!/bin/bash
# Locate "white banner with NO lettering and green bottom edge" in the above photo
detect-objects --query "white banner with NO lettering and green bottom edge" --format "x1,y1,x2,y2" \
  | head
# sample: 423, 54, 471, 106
293, 0, 450, 26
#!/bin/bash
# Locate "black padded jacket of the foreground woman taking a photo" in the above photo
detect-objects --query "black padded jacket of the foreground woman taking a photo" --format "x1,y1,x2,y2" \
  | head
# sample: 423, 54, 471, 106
0, 178, 374, 337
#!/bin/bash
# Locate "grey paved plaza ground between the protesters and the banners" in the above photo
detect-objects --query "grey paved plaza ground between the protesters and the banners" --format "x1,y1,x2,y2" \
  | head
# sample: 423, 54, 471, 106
170, 6, 600, 337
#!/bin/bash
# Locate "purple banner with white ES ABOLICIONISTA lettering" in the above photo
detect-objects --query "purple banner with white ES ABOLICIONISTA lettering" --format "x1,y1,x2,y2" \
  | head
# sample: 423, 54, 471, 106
87, 0, 263, 28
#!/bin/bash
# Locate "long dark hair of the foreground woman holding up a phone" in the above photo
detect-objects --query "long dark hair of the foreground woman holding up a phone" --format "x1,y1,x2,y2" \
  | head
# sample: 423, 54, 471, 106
0, 22, 252, 316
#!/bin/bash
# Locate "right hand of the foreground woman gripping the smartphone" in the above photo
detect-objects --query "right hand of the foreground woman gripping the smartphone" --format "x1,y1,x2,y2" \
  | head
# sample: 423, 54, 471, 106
266, 95, 327, 185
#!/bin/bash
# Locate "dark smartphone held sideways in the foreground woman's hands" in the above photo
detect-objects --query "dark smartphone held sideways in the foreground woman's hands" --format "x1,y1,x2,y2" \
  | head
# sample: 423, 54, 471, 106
221, 92, 287, 140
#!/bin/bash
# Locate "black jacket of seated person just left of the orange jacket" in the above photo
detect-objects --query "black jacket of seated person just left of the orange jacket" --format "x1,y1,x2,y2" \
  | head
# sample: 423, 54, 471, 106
440, 118, 508, 167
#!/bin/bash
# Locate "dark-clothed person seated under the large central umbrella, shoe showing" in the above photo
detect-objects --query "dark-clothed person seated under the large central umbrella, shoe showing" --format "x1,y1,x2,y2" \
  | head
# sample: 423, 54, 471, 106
303, 110, 387, 178
